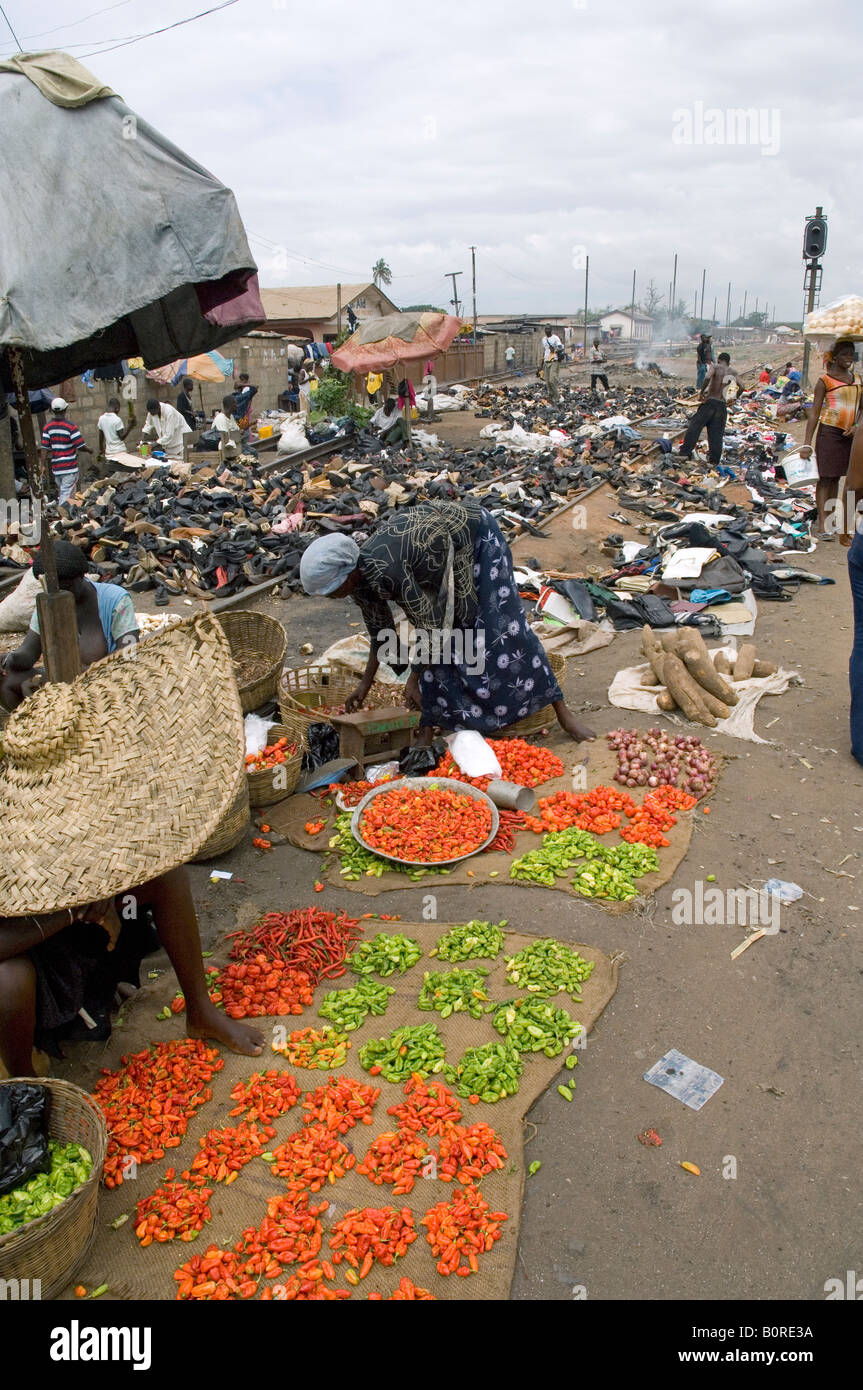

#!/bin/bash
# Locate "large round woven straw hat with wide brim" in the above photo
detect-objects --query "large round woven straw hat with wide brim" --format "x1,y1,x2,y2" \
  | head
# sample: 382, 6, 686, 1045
0, 614, 245, 916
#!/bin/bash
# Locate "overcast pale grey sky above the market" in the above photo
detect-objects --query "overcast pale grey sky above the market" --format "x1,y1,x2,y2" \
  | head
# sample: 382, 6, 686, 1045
0, 0, 863, 321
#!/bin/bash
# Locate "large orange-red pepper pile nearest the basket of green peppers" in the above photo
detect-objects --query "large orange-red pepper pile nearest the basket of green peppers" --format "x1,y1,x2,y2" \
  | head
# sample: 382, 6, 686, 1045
93, 1038, 225, 1187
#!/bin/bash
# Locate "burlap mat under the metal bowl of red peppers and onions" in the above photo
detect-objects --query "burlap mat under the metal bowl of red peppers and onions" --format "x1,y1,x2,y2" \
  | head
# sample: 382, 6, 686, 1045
265, 738, 705, 913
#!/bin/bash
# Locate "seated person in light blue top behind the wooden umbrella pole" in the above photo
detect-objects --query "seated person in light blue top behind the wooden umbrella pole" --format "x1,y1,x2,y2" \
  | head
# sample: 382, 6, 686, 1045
0, 541, 139, 709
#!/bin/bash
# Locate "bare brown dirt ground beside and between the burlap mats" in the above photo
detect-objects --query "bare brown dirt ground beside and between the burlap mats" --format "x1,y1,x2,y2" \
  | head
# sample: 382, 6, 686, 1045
47, 348, 863, 1300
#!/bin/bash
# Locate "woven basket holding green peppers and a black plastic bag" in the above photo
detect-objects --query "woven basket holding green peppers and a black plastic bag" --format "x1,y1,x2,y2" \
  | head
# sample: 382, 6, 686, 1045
0, 1076, 108, 1300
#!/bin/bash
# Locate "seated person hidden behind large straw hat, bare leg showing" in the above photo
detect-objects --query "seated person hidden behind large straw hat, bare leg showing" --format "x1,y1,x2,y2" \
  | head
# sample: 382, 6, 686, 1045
0, 614, 264, 1076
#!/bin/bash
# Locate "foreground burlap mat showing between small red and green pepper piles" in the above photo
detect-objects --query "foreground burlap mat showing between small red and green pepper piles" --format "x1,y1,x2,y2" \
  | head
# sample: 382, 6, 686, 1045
63, 913, 618, 1300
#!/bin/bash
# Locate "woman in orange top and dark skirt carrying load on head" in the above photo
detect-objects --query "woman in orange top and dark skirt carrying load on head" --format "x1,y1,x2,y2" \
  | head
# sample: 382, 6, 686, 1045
800, 339, 862, 541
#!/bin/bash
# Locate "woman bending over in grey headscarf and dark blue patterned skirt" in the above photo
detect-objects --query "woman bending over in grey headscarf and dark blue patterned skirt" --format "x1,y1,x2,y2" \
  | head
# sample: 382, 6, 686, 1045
300, 498, 593, 741
